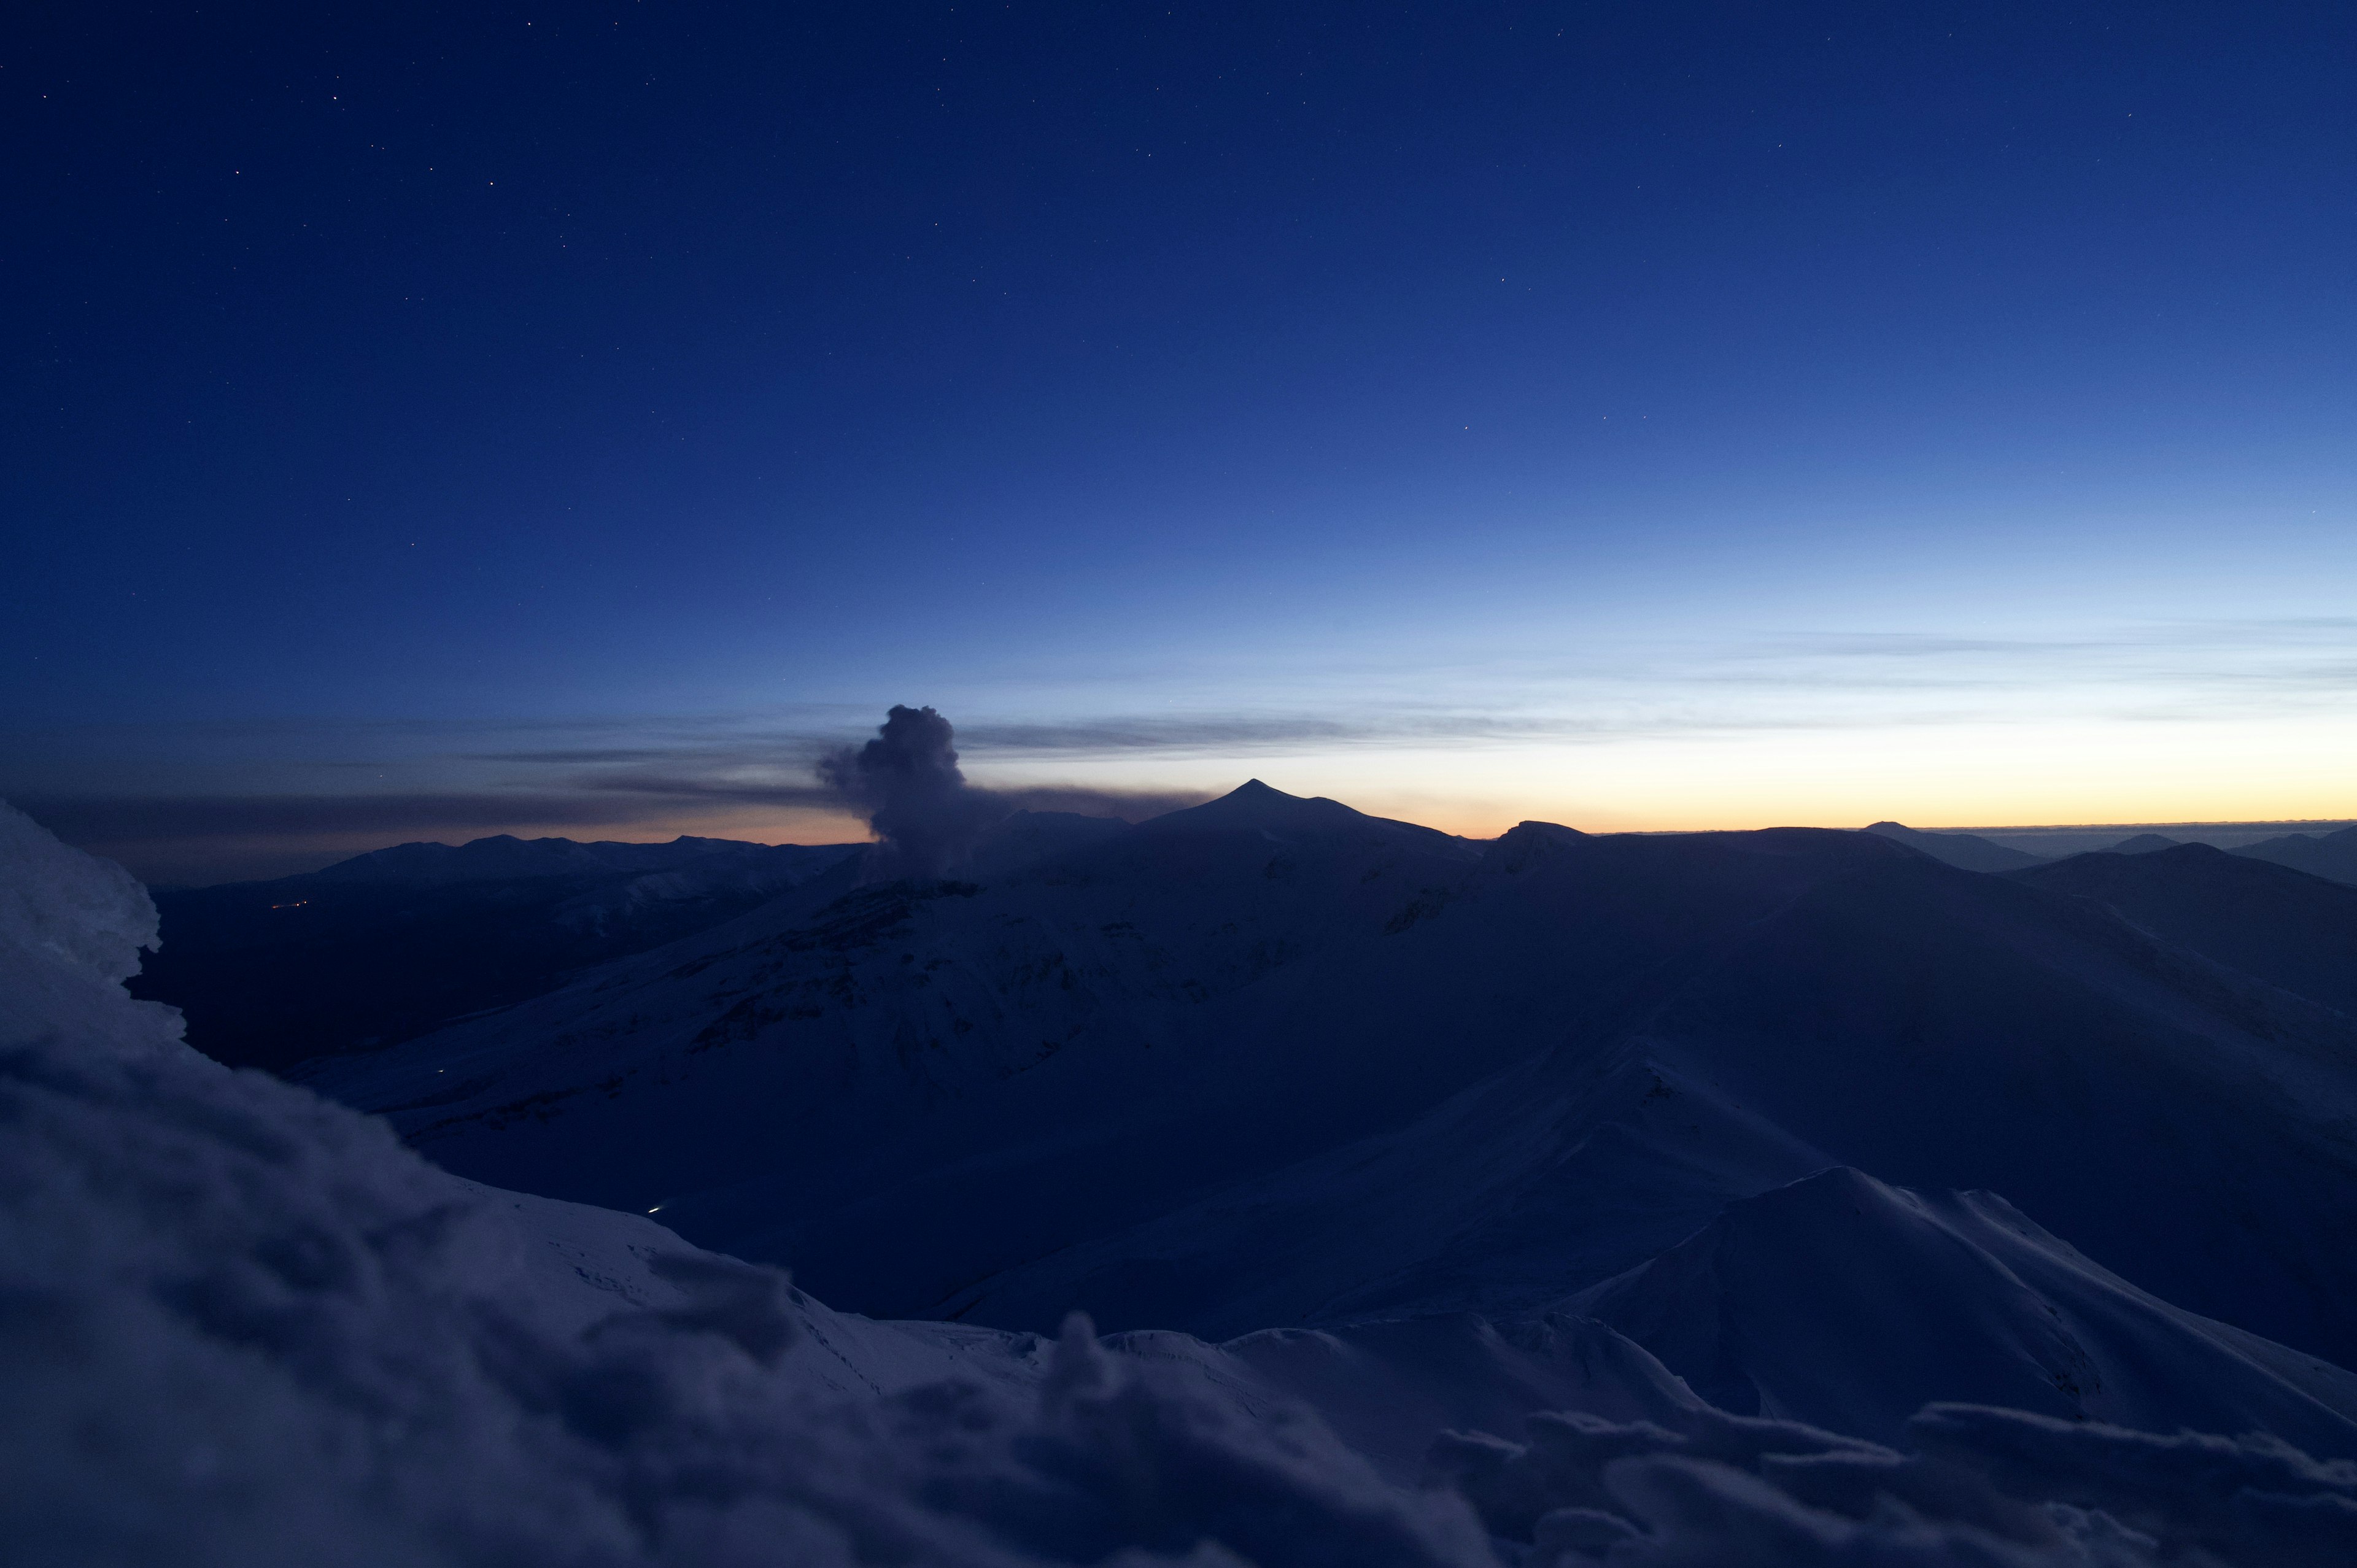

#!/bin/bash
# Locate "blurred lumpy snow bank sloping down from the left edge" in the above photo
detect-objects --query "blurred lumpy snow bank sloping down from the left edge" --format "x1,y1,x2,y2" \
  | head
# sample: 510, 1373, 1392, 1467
0, 801, 1485, 1568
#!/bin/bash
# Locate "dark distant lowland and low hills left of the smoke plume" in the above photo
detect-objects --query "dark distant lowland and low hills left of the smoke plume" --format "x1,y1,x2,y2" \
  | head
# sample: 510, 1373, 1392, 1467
132, 835, 858, 1068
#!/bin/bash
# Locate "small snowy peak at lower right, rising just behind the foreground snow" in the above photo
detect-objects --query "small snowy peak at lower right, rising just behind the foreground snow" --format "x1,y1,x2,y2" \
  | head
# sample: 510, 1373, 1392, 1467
1565, 1167, 2357, 1457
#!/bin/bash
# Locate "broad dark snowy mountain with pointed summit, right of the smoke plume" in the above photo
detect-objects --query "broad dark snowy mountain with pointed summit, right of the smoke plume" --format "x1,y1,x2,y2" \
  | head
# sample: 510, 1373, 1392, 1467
314, 785, 2357, 1358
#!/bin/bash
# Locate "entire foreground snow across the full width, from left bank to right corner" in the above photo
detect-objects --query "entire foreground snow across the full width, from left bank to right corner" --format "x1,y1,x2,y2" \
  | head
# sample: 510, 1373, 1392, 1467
0, 806, 2357, 1568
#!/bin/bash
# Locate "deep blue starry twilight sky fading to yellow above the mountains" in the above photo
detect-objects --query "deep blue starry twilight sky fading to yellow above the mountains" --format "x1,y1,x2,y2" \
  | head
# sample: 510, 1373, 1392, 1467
0, 0, 2357, 882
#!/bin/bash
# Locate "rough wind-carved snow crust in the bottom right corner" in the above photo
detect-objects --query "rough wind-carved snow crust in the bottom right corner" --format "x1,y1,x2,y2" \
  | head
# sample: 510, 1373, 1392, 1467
1433, 1405, 2357, 1568
